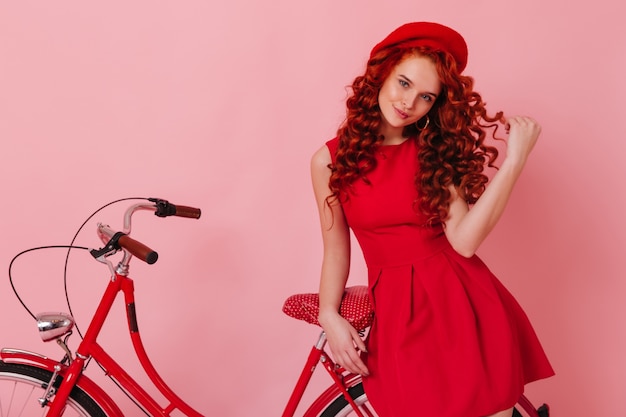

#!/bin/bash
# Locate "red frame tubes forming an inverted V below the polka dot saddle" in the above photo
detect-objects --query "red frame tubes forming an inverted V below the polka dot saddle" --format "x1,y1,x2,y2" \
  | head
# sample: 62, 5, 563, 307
282, 331, 366, 417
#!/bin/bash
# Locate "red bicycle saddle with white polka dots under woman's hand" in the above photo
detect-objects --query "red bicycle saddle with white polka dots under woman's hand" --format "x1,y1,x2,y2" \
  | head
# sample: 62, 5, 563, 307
283, 285, 374, 331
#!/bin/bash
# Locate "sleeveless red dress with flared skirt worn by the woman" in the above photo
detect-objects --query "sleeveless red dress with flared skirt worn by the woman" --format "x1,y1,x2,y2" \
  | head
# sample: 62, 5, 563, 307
327, 138, 554, 417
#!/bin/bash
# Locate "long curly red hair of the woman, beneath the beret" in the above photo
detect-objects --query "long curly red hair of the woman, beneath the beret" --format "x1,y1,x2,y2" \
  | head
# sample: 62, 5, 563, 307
328, 47, 503, 223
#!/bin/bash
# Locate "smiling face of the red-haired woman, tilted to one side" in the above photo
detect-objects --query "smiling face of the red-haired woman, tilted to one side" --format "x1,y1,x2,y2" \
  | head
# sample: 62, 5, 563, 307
378, 55, 441, 136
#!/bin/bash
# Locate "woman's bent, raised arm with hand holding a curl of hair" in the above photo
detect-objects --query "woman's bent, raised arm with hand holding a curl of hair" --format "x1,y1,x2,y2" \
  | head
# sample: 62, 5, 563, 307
445, 116, 541, 257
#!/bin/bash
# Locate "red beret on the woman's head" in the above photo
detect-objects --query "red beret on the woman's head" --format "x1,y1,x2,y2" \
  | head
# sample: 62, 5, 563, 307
370, 22, 467, 72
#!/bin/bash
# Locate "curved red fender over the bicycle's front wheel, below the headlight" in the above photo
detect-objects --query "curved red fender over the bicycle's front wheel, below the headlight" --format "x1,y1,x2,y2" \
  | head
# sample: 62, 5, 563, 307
0, 348, 124, 417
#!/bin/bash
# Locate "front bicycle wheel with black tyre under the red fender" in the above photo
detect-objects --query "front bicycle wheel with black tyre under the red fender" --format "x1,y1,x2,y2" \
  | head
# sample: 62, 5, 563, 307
0, 361, 108, 417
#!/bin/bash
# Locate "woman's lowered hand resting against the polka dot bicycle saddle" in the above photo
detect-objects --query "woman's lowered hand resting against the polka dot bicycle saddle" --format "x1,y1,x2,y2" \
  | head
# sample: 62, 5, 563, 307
319, 312, 369, 376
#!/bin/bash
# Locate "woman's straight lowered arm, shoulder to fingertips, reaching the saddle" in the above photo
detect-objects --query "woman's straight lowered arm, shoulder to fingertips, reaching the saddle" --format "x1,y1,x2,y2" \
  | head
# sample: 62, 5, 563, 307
311, 146, 368, 375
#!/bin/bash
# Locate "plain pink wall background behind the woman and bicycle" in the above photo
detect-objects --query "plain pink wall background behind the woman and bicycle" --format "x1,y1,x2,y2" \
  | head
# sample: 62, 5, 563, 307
0, 0, 626, 417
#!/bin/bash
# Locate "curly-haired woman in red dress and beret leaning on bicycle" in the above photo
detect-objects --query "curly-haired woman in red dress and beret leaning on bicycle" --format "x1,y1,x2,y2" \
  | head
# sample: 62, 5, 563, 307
311, 22, 553, 417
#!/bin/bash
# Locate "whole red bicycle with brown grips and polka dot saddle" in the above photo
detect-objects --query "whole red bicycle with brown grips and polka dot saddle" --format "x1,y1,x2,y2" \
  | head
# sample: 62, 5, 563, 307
0, 199, 548, 417
